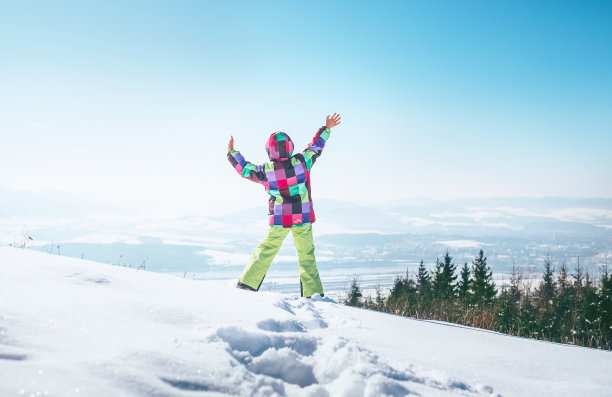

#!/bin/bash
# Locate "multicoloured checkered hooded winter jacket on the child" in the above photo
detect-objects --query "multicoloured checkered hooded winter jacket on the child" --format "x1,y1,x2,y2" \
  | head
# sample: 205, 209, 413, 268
227, 126, 330, 227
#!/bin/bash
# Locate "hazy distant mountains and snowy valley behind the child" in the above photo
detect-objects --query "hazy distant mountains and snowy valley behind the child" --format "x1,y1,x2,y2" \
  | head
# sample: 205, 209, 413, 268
0, 189, 612, 273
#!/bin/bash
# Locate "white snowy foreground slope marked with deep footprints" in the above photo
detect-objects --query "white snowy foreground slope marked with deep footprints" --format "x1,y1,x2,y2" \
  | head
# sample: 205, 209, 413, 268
0, 247, 612, 397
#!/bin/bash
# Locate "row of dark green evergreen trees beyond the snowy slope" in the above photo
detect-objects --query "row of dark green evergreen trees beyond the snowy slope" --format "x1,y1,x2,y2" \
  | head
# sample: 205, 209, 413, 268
344, 250, 612, 350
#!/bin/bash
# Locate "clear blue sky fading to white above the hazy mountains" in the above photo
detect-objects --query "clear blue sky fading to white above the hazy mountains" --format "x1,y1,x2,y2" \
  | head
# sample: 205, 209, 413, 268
0, 0, 612, 217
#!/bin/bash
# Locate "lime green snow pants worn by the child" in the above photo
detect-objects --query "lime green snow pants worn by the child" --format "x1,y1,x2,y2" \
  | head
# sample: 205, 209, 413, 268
238, 224, 323, 297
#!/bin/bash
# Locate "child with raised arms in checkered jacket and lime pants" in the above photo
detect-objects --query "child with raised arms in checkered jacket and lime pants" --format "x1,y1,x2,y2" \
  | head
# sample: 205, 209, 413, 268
227, 113, 340, 297
